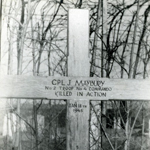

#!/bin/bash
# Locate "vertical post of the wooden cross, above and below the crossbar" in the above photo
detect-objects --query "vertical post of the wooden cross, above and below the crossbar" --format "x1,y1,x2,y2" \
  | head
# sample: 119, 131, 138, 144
67, 9, 90, 150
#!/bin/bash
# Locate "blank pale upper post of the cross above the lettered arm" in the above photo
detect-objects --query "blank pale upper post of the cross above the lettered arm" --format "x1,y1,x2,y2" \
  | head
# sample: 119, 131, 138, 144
68, 9, 90, 77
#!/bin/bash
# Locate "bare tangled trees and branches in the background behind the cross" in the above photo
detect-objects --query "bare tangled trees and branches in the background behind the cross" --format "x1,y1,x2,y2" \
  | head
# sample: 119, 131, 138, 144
0, 0, 150, 150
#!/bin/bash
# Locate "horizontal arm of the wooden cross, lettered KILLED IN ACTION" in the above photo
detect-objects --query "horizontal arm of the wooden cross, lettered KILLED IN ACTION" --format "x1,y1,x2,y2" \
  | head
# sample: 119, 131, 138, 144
0, 76, 150, 100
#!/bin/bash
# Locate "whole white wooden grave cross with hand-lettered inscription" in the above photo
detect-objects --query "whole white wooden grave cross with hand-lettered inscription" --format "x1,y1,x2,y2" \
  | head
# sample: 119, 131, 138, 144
0, 9, 150, 150
